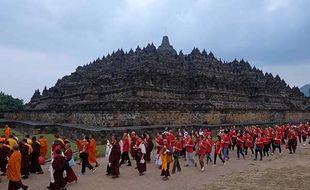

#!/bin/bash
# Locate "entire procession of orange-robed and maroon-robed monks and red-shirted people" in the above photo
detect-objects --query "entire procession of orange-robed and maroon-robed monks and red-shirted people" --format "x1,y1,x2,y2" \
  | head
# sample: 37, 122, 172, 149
0, 123, 310, 190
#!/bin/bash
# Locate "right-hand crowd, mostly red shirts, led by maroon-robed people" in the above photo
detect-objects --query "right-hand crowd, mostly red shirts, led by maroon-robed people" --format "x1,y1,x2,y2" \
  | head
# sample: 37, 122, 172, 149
106, 123, 310, 181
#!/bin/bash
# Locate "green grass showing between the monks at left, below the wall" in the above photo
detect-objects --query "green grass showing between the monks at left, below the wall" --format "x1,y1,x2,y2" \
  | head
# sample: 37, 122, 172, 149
0, 128, 106, 159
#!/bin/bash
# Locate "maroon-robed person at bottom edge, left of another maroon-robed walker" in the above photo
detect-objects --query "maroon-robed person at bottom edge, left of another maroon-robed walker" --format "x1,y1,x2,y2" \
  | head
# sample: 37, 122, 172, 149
48, 150, 66, 190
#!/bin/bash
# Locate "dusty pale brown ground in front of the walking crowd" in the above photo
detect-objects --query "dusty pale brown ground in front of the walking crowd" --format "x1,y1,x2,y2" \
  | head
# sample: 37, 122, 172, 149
0, 142, 310, 190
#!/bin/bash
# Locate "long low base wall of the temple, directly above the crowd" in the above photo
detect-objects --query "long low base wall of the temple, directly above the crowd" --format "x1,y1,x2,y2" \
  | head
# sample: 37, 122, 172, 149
4, 111, 310, 127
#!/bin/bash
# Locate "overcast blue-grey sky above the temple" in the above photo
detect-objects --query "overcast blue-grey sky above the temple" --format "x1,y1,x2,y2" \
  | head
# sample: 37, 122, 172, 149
0, 0, 310, 102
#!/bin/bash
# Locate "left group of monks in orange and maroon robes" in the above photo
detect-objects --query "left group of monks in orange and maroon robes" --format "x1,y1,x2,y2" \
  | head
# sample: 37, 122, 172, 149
0, 125, 99, 190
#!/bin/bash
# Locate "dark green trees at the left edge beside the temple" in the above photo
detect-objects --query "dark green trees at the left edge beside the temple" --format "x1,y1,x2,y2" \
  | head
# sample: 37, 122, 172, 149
0, 92, 25, 111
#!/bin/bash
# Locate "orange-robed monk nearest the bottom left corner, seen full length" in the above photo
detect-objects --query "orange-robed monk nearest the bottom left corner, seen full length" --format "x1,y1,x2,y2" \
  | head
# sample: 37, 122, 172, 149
7, 144, 28, 190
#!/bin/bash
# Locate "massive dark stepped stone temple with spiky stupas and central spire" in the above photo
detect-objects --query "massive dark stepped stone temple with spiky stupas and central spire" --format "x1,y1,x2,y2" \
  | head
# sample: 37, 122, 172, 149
7, 36, 310, 127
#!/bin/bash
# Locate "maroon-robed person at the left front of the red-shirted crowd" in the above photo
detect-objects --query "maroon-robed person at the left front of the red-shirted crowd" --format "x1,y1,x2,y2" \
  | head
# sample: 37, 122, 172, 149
109, 136, 121, 179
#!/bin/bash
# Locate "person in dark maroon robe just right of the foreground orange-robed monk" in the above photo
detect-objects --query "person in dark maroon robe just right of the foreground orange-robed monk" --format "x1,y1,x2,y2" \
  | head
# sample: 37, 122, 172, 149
19, 139, 30, 179
